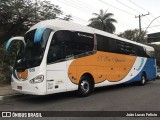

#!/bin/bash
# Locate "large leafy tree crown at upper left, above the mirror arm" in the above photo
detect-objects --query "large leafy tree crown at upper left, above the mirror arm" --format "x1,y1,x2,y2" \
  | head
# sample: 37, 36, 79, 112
0, 0, 71, 45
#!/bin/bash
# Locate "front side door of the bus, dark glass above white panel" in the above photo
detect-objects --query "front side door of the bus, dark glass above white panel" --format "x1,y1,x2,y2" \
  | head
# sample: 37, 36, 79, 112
47, 32, 67, 94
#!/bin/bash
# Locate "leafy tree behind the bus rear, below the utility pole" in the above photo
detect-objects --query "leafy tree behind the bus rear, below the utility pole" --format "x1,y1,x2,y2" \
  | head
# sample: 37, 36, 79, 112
118, 29, 147, 43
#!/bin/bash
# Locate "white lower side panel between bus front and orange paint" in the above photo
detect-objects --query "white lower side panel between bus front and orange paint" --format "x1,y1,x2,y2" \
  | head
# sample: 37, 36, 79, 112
46, 60, 78, 94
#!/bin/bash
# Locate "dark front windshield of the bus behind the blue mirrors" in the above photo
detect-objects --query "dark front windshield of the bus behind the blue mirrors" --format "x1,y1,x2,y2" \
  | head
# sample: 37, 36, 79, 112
14, 28, 51, 71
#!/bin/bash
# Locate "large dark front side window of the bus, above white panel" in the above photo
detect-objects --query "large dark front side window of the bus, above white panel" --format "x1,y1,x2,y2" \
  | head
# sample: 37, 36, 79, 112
47, 30, 94, 63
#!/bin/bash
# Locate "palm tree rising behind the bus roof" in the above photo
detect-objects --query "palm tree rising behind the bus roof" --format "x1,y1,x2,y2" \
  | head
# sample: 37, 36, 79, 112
88, 9, 117, 33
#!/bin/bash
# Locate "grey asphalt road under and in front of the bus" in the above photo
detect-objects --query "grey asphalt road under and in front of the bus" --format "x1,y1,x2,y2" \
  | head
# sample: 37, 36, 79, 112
0, 80, 160, 120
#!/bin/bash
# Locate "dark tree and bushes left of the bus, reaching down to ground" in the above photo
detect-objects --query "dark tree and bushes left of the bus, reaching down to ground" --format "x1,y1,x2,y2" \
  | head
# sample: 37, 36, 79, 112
0, 0, 72, 82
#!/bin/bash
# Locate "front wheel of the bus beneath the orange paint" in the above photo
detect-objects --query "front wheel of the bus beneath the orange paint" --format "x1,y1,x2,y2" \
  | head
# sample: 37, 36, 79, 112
78, 76, 94, 97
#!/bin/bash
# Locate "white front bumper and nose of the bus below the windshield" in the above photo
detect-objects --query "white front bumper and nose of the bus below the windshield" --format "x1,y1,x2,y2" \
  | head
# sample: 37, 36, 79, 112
11, 67, 46, 95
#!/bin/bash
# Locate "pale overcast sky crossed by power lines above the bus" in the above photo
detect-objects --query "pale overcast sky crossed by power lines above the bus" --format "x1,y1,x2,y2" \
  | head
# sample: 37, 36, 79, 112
51, 0, 160, 34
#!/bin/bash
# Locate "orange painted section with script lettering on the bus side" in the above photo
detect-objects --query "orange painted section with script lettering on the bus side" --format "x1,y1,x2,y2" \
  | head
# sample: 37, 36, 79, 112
68, 52, 136, 84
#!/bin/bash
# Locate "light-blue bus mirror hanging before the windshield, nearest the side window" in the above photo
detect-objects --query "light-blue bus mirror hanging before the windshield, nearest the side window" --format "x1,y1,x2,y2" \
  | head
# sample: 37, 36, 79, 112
34, 28, 45, 43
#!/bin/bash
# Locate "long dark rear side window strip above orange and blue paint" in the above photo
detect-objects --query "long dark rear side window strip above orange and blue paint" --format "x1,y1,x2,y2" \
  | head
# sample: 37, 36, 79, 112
96, 35, 155, 58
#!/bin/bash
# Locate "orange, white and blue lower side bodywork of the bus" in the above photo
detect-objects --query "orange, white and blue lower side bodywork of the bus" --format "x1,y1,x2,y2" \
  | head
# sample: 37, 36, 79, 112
68, 52, 155, 86
